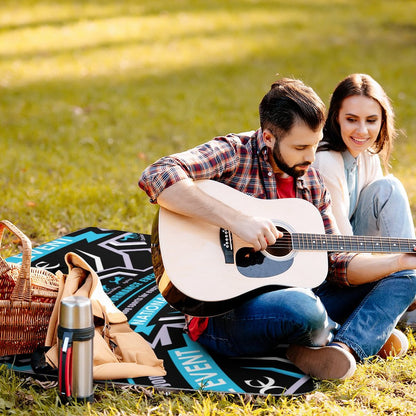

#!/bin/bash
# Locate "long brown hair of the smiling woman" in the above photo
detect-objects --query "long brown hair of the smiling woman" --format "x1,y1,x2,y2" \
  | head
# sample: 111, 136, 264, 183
318, 74, 397, 170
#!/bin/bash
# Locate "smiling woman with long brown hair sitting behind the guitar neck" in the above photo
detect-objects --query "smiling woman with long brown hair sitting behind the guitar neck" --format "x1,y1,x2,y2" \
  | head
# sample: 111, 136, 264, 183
314, 74, 415, 349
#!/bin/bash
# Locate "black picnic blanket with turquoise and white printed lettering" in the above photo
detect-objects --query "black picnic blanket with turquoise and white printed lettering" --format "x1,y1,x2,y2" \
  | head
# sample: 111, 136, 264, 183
0, 227, 315, 396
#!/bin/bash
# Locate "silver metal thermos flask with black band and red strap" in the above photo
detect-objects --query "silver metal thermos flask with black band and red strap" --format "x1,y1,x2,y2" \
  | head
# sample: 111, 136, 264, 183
58, 296, 94, 403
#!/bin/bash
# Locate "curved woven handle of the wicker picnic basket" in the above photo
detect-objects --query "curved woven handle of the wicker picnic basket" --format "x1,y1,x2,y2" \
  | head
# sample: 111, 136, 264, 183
0, 220, 32, 302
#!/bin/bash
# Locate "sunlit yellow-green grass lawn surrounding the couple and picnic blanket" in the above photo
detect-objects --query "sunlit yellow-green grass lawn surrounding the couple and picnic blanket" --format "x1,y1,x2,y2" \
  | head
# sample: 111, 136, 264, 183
0, 0, 416, 415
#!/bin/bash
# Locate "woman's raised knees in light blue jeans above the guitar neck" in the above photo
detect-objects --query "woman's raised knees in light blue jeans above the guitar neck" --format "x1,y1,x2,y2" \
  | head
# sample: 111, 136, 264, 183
350, 175, 415, 238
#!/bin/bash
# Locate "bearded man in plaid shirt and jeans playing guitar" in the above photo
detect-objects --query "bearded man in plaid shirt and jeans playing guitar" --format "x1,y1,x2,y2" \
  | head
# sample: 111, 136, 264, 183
139, 78, 416, 379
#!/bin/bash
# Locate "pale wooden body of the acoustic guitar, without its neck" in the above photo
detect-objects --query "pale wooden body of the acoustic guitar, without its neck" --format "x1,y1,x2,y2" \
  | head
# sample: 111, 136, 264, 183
152, 180, 328, 316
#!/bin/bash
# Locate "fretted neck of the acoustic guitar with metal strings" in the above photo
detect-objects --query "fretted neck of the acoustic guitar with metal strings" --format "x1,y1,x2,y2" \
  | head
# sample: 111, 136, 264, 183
291, 233, 416, 253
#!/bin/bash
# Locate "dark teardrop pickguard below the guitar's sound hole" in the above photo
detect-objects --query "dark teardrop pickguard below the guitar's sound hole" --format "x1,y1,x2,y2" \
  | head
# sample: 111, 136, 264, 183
235, 247, 293, 278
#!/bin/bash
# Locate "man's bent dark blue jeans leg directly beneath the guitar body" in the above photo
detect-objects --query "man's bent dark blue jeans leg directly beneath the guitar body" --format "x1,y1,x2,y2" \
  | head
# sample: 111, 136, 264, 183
198, 288, 337, 356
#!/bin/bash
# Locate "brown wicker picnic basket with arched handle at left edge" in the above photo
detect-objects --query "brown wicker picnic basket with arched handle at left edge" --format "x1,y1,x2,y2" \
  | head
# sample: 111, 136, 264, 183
0, 220, 58, 356
